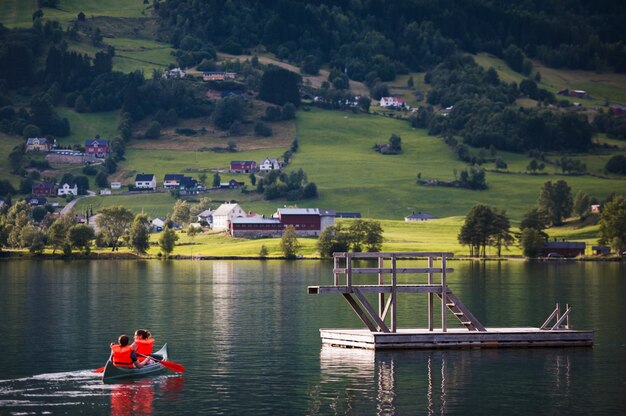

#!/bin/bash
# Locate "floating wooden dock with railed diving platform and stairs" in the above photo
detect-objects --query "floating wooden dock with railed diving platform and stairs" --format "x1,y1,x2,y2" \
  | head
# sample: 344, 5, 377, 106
308, 252, 593, 350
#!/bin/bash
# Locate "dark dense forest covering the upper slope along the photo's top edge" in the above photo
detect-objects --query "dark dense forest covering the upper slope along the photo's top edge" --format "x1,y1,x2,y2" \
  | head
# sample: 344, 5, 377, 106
158, 0, 626, 74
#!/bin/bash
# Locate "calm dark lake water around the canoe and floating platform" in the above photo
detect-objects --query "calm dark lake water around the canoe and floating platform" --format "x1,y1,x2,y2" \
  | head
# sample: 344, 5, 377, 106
0, 260, 626, 415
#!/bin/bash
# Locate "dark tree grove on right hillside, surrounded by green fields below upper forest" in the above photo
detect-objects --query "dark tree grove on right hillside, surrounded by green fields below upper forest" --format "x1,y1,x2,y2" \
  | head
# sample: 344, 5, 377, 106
411, 55, 593, 152
